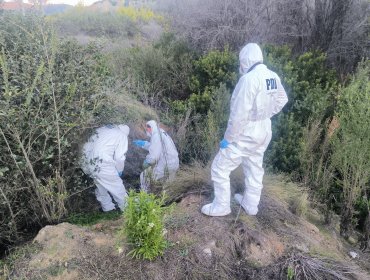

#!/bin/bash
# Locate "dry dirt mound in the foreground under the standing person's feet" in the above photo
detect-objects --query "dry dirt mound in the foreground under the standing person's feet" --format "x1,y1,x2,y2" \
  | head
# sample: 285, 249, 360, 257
6, 176, 370, 279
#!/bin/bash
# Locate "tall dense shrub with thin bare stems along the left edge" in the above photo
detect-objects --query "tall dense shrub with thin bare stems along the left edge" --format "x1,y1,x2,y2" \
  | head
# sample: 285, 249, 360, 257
0, 15, 108, 247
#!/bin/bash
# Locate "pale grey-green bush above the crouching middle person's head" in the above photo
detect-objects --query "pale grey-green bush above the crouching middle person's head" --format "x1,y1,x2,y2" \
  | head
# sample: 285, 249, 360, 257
111, 34, 193, 108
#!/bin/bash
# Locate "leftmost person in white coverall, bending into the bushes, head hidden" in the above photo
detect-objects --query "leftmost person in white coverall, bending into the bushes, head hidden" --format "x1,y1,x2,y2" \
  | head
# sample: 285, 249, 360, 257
82, 125, 130, 212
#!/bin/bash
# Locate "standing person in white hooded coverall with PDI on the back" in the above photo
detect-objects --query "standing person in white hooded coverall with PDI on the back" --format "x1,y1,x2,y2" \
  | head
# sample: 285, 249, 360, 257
201, 43, 288, 216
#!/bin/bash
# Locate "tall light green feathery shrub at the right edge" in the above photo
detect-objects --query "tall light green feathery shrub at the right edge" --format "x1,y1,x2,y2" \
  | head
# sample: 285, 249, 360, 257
301, 62, 370, 237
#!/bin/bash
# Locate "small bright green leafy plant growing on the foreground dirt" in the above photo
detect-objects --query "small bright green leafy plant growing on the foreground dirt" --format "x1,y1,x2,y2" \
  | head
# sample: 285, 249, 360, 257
123, 191, 166, 260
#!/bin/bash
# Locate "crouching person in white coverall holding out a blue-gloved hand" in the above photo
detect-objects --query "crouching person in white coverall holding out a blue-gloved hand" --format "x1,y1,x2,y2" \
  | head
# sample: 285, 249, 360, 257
133, 120, 179, 192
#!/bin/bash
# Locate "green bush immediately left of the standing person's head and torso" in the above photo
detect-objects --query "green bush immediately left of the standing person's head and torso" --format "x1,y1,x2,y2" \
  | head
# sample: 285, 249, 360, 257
163, 48, 237, 163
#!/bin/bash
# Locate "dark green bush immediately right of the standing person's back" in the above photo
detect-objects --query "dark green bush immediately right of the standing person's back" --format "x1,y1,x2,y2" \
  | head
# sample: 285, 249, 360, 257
264, 45, 338, 174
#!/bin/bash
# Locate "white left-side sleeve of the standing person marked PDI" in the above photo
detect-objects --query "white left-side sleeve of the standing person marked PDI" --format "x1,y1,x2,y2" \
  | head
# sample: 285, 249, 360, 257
224, 76, 255, 143
